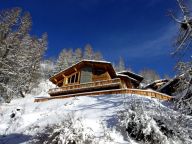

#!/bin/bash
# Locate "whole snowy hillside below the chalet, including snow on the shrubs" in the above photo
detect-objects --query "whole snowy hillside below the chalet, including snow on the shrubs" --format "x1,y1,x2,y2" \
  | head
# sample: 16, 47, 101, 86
0, 82, 191, 144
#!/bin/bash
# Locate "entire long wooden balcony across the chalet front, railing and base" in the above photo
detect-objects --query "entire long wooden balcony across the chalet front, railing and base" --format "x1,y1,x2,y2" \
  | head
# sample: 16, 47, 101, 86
48, 78, 121, 96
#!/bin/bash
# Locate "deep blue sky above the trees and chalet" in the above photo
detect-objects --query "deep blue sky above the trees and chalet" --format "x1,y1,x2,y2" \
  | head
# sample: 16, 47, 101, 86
0, 0, 178, 76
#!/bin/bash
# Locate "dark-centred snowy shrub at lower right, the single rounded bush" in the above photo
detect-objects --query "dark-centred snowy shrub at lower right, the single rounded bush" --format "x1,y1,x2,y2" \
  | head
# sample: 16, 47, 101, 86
117, 105, 170, 143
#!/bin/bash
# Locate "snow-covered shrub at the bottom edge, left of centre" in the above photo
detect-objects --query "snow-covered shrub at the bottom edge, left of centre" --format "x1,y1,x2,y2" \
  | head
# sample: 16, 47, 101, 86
31, 115, 95, 144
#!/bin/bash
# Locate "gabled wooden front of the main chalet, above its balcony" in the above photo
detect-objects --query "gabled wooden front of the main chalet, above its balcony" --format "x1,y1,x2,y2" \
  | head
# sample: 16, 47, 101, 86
50, 60, 116, 87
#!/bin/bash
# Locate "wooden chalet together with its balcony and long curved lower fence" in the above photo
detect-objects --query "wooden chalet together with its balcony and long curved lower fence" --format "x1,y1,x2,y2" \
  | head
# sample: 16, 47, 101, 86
35, 60, 172, 101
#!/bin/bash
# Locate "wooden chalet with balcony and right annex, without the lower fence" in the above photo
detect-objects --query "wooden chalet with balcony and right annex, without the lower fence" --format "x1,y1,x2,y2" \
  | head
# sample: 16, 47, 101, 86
49, 60, 141, 96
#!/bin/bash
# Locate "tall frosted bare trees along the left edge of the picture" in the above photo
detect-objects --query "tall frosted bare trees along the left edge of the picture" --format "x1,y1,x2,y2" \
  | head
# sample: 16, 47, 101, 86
0, 8, 47, 102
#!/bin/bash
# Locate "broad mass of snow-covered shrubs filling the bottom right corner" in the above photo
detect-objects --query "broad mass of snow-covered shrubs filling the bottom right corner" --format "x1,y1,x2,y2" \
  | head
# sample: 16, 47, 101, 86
117, 98, 192, 144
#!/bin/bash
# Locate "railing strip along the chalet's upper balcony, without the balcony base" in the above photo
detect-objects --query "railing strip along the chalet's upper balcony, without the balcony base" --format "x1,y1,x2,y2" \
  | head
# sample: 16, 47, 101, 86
48, 78, 121, 94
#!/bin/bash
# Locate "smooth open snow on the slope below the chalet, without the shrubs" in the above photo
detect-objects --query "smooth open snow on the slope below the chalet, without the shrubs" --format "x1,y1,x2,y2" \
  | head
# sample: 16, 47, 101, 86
0, 82, 182, 144
